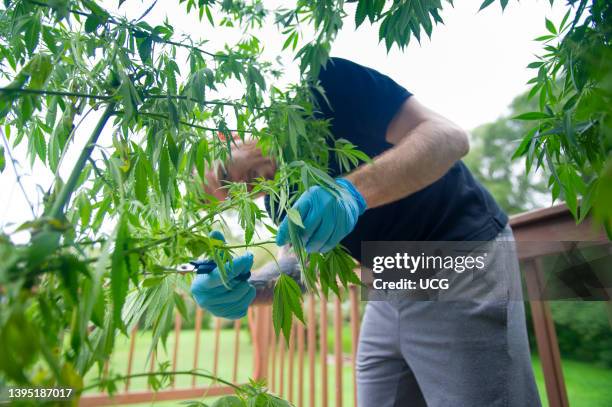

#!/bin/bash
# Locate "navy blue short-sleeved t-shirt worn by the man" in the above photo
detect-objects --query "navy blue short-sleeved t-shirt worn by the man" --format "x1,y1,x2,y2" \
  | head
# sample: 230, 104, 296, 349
272, 58, 508, 260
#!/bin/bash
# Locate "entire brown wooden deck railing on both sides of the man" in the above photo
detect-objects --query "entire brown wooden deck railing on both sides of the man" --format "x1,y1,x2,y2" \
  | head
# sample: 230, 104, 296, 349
81, 205, 606, 407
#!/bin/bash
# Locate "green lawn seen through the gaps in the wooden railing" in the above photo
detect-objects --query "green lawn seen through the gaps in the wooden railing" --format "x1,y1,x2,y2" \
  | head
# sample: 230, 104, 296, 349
86, 329, 612, 407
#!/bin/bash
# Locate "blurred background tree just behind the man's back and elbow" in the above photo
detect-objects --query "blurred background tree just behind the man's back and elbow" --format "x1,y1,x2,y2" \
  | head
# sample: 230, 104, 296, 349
464, 94, 548, 214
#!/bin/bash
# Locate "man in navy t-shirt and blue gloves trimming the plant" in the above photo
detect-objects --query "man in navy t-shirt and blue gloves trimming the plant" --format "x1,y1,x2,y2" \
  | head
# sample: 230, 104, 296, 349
192, 58, 540, 407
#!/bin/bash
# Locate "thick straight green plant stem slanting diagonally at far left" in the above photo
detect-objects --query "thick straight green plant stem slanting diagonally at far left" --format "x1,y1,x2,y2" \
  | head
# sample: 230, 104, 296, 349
49, 102, 115, 222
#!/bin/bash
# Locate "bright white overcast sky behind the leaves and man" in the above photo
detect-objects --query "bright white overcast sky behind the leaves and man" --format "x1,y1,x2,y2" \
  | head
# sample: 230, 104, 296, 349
0, 0, 566, 236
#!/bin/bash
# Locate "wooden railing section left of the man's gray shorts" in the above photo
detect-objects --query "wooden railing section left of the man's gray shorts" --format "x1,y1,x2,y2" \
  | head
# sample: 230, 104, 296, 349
80, 286, 361, 407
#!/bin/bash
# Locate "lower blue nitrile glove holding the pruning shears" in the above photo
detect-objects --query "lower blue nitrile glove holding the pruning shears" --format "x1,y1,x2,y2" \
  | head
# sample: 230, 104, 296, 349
191, 232, 255, 319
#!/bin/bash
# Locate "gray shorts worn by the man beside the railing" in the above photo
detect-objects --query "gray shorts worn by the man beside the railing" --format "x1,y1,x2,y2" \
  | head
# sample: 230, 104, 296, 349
357, 227, 541, 407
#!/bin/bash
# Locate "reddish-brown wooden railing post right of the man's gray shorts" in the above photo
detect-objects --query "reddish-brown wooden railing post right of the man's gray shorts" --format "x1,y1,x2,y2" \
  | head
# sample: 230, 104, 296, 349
524, 258, 569, 407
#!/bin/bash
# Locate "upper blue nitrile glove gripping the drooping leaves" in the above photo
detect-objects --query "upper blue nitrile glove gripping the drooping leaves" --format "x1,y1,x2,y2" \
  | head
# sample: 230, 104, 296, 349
276, 178, 366, 253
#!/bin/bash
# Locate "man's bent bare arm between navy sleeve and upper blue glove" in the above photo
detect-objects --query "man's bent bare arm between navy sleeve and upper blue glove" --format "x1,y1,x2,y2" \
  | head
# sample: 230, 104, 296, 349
346, 97, 469, 208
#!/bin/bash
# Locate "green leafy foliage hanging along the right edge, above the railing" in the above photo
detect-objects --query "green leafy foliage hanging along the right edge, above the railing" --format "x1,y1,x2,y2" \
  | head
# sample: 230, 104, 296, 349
510, 0, 612, 234
